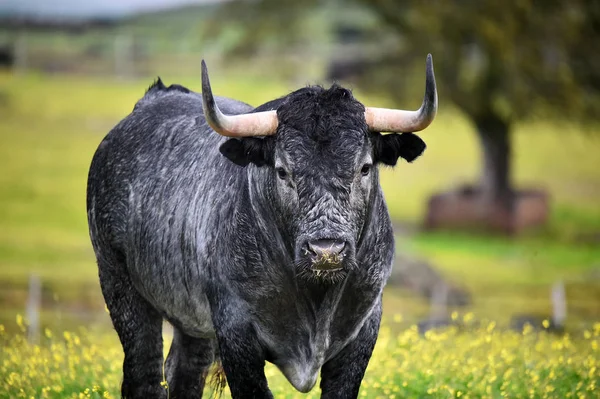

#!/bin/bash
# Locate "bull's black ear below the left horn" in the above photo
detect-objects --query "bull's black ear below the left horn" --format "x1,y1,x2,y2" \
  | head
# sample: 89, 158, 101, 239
219, 137, 274, 166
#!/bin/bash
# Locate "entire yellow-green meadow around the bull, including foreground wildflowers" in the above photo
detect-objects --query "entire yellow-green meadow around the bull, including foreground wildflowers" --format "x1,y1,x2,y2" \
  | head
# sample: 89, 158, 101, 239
0, 71, 600, 398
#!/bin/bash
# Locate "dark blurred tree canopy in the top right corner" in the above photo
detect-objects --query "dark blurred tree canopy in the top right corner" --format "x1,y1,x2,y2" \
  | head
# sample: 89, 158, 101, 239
356, 0, 600, 122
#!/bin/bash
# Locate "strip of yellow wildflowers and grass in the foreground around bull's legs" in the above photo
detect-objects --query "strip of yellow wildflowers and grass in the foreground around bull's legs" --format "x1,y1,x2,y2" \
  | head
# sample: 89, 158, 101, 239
0, 322, 600, 399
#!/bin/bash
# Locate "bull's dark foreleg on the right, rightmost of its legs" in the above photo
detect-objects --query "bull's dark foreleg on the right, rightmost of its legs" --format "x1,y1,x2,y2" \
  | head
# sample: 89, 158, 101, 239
321, 305, 381, 399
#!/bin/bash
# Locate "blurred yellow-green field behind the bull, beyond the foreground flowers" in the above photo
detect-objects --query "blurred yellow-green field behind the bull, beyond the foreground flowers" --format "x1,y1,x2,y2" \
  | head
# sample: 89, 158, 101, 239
0, 70, 600, 332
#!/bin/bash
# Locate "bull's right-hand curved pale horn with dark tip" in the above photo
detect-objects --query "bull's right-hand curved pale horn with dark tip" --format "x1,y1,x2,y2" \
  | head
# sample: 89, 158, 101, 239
365, 54, 437, 133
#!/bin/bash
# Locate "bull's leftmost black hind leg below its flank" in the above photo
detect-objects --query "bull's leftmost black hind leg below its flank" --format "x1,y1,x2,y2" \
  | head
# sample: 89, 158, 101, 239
98, 259, 166, 399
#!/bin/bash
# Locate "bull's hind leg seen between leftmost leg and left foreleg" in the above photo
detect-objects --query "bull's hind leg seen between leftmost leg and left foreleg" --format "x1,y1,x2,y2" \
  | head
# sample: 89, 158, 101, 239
166, 328, 216, 399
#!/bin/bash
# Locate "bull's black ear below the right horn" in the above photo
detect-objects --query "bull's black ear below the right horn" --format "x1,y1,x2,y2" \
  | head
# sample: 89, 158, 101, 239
371, 133, 427, 166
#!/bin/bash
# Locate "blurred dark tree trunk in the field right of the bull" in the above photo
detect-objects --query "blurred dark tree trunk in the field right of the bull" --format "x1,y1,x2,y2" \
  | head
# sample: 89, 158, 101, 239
475, 115, 513, 208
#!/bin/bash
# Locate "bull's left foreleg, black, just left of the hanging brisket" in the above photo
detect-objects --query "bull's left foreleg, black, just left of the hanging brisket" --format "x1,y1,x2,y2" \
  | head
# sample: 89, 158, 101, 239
209, 297, 273, 399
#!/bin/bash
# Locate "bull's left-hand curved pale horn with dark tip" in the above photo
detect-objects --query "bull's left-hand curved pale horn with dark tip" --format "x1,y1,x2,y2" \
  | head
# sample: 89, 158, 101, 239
202, 60, 278, 137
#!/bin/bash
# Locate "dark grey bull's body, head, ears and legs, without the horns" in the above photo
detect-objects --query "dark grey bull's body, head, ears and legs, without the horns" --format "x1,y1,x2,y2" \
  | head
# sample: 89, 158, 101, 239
87, 60, 436, 399
